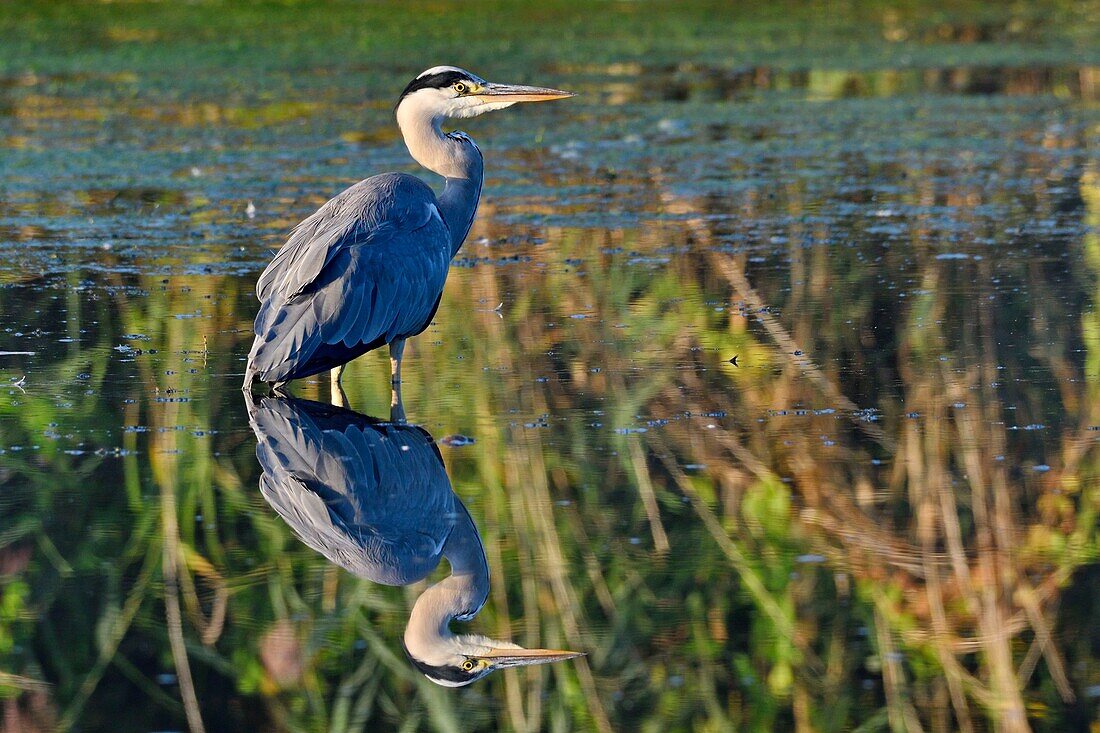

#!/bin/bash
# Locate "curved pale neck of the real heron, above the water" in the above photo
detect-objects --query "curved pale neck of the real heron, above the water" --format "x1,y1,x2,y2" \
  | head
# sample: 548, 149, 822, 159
397, 104, 485, 258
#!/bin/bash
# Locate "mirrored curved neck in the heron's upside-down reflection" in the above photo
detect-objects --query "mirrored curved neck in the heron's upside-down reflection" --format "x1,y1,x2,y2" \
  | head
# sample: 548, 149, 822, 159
405, 503, 488, 659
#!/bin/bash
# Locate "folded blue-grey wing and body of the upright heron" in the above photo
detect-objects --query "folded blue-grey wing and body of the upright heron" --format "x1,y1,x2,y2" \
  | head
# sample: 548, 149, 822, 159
249, 174, 450, 382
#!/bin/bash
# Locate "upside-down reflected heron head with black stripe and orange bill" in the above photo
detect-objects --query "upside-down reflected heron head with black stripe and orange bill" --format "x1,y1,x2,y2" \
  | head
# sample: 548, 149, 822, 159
404, 634, 584, 687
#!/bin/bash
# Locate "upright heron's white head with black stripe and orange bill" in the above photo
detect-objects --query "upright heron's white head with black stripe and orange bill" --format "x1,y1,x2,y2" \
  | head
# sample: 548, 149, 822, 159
397, 66, 573, 119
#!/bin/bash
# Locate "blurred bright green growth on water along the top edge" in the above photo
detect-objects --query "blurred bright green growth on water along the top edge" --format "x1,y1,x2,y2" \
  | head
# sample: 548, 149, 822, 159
0, 0, 1100, 98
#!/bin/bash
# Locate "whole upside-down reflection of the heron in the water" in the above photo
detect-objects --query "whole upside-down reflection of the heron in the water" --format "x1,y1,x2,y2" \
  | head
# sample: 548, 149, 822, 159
246, 396, 580, 687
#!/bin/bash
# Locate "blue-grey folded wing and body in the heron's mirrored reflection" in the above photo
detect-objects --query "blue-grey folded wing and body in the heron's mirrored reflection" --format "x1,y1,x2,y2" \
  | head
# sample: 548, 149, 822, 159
250, 398, 455, 586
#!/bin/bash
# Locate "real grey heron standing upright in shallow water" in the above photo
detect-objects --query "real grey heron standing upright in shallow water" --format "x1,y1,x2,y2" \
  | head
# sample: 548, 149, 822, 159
243, 66, 573, 402
